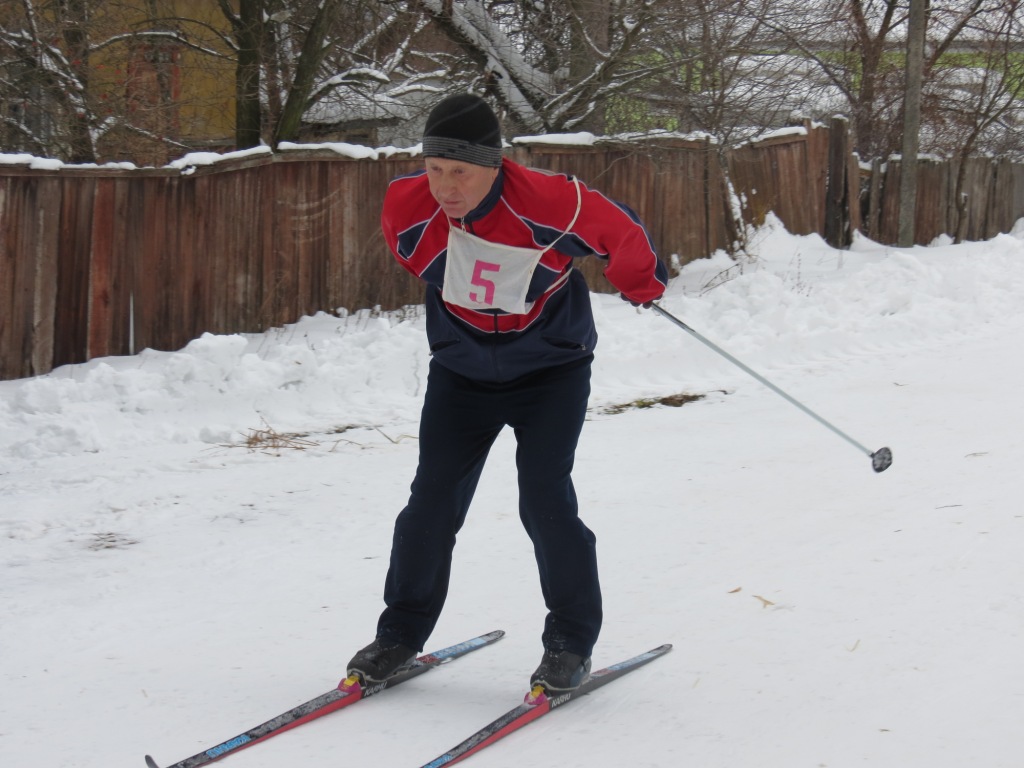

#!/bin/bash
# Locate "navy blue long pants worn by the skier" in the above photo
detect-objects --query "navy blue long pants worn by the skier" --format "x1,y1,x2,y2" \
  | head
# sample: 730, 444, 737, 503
377, 357, 602, 656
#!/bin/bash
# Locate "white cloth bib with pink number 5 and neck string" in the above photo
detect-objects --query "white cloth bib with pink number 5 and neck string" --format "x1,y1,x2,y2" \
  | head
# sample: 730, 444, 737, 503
441, 179, 583, 314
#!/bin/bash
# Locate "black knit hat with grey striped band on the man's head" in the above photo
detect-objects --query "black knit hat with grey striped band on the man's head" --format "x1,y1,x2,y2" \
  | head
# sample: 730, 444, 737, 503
423, 93, 502, 168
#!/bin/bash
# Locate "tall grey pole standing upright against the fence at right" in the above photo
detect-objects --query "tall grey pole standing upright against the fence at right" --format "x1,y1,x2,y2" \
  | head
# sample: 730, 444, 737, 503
897, 0, 928, 248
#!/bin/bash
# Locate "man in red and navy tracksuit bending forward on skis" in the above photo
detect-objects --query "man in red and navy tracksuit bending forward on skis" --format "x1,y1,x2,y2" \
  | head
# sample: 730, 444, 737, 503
348, 95, 668, 693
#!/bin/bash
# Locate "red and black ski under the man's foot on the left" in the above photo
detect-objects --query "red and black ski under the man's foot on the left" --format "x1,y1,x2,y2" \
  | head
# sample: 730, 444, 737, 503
145, 630, 505, 768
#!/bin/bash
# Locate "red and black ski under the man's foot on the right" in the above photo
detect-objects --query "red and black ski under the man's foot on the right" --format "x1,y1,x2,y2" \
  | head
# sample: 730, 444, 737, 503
420, 644, 672, 768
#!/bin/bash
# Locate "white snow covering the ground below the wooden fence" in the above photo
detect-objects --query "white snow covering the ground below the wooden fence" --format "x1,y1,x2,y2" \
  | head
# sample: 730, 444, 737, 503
0, 211, 1024, 768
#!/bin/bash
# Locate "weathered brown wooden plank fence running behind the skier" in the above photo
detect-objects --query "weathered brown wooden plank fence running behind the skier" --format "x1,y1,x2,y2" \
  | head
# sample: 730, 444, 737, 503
0, 121, 1024, 379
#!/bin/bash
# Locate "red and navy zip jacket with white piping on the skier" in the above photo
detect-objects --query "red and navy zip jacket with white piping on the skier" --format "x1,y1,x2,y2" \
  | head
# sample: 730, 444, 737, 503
381, 159, 669, 382
